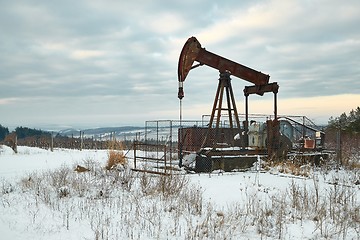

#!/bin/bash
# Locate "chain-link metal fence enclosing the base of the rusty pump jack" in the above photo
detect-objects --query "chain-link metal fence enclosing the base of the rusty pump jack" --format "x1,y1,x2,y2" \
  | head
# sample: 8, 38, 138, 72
144, 114, 324, 171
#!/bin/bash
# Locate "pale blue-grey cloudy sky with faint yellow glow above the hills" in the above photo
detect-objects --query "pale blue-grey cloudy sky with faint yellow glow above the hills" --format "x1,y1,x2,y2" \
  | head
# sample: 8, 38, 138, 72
0, 0, 360, 128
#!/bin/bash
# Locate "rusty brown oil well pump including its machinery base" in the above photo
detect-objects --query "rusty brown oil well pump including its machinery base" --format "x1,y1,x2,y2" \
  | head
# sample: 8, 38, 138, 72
178, 37, 290, 172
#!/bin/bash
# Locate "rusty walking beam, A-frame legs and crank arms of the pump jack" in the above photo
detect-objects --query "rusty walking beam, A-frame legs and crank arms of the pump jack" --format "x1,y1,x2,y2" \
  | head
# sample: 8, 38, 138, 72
178, 37, 280, 171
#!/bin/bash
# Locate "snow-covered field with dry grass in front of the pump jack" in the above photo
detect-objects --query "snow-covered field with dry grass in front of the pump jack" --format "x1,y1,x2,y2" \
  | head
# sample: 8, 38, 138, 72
0, 146, 360, 240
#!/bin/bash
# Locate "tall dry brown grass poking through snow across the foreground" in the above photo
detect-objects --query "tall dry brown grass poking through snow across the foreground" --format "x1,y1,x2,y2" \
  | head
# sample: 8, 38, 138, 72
0, 160, 360, 239
